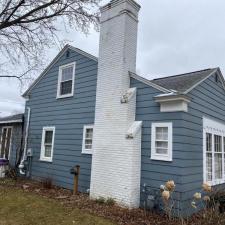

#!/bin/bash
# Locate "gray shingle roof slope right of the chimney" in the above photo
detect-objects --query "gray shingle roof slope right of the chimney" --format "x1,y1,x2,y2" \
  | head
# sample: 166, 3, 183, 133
151, 68, 217, 93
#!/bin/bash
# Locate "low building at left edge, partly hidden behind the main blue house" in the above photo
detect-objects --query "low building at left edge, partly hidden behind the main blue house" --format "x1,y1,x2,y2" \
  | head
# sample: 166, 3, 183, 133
0, 114, 23, 167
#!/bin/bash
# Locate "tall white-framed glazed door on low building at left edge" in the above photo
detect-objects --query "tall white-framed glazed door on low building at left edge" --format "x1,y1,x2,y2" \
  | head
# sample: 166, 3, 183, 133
0, 127, 12, 159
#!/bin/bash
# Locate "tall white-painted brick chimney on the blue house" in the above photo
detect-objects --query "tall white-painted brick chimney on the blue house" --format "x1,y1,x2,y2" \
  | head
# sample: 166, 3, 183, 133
90, 0, 141, 208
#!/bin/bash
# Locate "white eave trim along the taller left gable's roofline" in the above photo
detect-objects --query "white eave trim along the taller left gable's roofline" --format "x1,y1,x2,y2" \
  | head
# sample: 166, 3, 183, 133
22, 45, 98, 98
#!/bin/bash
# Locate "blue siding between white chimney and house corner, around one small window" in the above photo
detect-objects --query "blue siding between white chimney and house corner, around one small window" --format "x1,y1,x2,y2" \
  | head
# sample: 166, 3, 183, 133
131, 78, 185, 214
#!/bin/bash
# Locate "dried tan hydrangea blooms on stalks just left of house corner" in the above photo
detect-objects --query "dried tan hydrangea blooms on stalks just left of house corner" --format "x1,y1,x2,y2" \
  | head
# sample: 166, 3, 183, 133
160, 180, 176, 219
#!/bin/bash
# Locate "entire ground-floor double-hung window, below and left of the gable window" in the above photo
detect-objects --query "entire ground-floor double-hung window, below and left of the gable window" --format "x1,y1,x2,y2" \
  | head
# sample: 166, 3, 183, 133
40, 127, 55, 162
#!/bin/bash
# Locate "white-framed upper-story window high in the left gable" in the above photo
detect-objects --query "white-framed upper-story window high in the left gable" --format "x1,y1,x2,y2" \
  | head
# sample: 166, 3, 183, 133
57, 62, 76, 98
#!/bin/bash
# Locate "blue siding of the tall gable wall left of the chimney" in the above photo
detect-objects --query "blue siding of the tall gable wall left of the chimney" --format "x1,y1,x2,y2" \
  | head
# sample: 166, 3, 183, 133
26, 50, 97, 192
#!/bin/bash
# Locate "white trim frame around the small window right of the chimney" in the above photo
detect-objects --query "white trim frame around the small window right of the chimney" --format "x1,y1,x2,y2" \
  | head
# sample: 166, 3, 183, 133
151, 122, 173, 161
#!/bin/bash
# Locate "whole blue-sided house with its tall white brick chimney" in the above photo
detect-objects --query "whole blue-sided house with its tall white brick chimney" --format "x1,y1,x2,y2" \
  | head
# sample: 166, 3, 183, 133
18, 0, 225, 215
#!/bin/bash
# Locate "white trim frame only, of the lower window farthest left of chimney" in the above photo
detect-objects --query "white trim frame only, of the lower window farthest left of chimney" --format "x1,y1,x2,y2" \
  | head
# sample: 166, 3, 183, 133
40, 127, 55, 162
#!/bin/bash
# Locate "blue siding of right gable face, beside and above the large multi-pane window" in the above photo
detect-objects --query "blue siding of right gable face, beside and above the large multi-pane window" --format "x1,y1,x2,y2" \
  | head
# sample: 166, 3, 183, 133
182, 75, 225, 214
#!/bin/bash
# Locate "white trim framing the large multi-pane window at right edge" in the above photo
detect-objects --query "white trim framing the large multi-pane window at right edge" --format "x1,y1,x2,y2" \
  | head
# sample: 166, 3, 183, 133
203, 117, 225, 186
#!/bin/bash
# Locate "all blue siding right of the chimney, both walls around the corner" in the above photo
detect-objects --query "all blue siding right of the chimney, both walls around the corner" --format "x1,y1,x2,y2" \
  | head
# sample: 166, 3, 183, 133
131, 72, 225, 216
